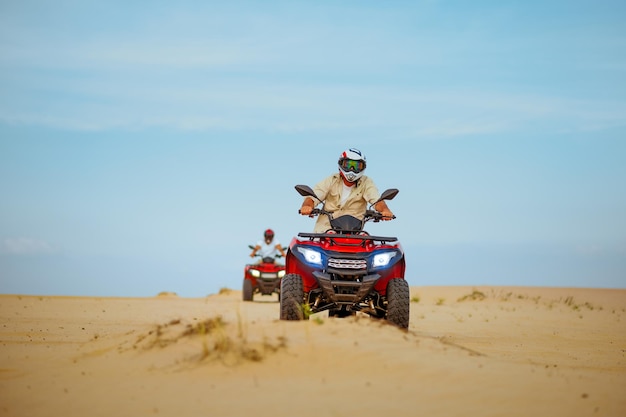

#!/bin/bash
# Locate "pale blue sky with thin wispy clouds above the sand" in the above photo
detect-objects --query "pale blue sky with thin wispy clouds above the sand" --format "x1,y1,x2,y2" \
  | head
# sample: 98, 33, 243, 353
0, 0, 626, 297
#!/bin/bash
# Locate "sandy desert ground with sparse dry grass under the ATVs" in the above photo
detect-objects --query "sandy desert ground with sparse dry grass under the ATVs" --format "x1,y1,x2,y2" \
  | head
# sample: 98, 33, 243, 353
0, 287, 626, 417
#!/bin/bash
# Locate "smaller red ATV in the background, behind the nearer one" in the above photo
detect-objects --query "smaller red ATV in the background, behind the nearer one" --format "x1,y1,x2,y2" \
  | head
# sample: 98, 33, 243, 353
243, 245, 285, 301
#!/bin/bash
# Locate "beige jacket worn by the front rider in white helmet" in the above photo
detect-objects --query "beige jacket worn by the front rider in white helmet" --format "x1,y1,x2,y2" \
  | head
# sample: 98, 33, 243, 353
304, 173, 380, 233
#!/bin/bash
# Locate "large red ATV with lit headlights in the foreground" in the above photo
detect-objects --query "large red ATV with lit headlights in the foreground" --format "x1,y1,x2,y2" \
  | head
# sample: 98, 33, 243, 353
280, 185, 410, 329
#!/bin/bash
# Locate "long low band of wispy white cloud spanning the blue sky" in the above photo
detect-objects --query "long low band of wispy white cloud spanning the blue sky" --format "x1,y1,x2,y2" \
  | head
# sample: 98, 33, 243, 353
0, 74, 626, 138
